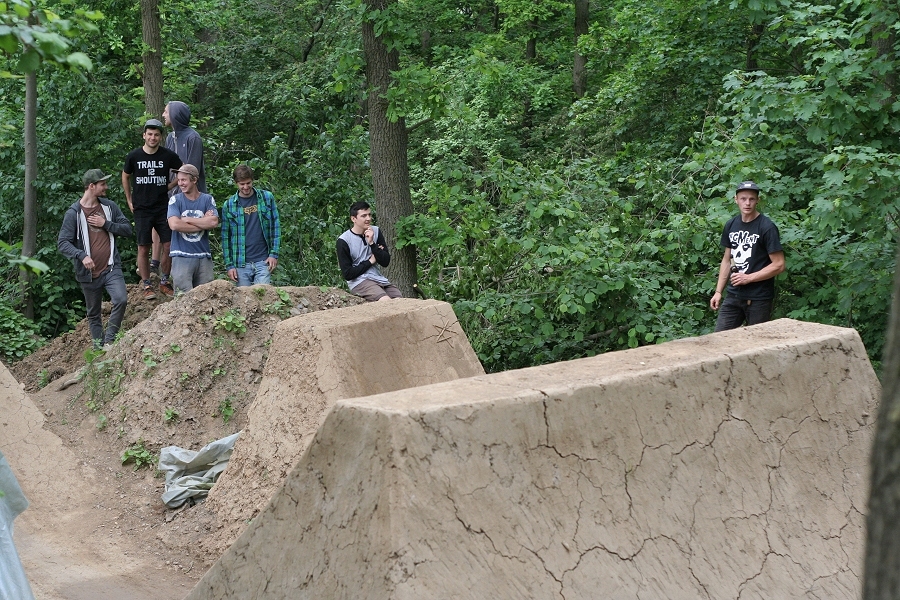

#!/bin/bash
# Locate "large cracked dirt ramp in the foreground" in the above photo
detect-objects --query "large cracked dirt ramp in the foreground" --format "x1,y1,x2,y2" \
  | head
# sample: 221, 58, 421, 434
188, 320, 879, 600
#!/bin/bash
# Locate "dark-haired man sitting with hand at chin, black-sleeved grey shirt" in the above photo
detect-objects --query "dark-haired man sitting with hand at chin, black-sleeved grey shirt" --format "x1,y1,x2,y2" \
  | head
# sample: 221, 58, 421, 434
337, 201, 403, 302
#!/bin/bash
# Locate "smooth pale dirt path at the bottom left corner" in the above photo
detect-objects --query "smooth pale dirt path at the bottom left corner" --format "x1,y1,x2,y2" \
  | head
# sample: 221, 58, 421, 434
0, 369, 202, 600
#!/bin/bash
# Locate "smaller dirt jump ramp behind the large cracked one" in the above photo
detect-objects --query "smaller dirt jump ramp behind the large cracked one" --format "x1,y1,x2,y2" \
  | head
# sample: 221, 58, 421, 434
206, 299, 484, 549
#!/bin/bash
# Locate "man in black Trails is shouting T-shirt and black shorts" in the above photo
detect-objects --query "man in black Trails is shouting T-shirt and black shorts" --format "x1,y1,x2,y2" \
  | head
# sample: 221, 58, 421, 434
122, 119, 181, 300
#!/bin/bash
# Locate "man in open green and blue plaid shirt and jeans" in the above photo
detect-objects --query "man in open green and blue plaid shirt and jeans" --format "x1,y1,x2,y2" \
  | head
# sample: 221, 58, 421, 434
222, 165, 281, 286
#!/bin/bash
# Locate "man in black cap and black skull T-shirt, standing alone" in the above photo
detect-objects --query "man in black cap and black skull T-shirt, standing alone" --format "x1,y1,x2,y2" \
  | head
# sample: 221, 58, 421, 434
709, 181, 784, 331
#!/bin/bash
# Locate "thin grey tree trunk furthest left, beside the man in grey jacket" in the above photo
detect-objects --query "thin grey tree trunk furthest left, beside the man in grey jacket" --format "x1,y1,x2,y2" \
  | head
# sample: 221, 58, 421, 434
19, 71, 37, 320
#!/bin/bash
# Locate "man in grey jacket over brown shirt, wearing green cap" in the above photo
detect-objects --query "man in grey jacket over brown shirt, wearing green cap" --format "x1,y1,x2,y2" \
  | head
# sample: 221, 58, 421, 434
56, 169, 131, 348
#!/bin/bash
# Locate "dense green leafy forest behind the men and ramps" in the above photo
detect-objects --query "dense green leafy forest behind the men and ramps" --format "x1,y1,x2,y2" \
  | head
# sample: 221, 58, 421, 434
0, 0, 900, 371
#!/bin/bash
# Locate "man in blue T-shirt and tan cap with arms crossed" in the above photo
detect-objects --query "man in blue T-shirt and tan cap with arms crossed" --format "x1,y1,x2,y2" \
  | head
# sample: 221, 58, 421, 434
168, 165, 219, 292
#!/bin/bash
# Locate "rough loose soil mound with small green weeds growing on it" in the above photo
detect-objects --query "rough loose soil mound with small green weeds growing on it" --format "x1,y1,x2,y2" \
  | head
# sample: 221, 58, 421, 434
8, 280, 362, 592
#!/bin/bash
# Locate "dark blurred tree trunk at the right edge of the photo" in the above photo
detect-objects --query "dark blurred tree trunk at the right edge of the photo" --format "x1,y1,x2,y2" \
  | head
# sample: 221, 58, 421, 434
862, 243, 900, 600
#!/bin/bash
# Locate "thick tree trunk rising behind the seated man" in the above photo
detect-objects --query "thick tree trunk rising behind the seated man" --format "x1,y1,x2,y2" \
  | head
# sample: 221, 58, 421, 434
362, 0, 418, 298
